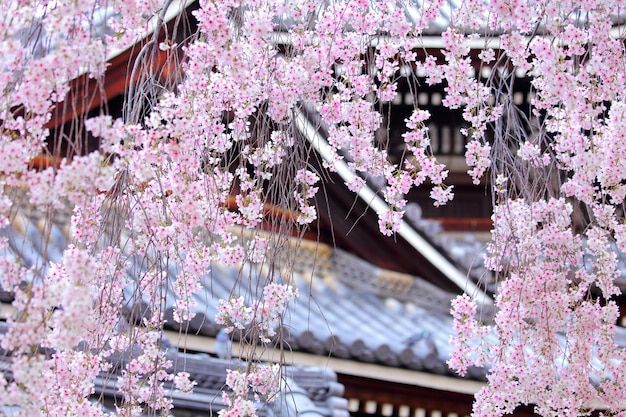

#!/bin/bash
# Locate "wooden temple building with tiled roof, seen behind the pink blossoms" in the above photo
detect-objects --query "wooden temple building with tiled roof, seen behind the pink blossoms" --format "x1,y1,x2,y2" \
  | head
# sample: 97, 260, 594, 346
0, 1, 624, 417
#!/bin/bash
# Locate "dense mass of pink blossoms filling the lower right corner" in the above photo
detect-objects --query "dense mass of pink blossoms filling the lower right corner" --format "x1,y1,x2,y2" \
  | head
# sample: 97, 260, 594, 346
449, 199, 626, 415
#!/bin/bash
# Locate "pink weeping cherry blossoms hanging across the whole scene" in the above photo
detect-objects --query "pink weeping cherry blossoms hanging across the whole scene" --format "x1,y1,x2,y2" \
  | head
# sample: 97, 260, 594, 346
0, 0, 626, 416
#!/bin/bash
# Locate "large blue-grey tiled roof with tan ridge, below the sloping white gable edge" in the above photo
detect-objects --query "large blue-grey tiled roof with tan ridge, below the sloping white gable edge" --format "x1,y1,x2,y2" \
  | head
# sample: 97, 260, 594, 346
0, 203, 481, 377
